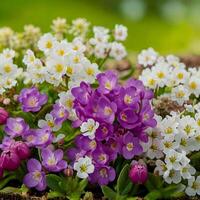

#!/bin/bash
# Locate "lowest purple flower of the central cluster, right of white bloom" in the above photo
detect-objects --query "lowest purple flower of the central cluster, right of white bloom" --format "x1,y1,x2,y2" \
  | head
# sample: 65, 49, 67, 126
90, 166, 116, 185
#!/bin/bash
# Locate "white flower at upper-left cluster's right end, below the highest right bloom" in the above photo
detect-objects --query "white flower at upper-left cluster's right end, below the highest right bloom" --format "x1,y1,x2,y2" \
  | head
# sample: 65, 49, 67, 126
110, 42, 127, 60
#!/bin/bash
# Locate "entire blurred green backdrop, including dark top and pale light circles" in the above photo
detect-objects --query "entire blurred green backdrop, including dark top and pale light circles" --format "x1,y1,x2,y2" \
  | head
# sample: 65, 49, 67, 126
0, 0, 200, 54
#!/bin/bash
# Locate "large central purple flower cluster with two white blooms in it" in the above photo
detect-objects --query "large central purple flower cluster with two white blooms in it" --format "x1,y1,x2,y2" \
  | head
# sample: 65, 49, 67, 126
68, 71, 156, 185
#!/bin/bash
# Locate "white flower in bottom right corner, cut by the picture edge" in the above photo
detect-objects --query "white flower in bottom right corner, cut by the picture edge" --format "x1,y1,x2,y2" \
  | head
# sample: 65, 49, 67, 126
185, 176, 200, 196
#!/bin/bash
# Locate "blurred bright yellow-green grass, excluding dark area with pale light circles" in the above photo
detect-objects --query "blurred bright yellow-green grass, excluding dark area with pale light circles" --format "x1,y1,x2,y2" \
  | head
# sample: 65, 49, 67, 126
0, 0, 200, 53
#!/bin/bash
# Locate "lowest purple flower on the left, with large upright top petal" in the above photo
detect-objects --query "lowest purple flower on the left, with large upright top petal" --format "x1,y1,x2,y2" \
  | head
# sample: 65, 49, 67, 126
23, 159, 47, 191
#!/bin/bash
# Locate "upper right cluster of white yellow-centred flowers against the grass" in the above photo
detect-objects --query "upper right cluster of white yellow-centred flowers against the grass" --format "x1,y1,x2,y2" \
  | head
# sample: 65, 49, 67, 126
138, 48, 200, 105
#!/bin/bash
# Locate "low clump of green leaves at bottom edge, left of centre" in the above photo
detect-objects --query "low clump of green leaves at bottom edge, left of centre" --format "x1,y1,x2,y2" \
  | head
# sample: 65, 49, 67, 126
46, 174, 87, 200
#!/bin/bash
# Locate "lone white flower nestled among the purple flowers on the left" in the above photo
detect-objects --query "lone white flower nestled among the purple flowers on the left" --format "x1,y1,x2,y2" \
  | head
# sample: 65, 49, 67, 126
38, 113, 61, 131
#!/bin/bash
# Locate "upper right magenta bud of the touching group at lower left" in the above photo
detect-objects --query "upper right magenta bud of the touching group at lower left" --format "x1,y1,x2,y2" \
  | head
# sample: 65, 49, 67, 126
14, 142, 30, 160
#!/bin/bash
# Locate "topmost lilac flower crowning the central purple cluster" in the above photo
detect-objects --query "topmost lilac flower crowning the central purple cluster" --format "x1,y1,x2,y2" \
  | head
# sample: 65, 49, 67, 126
97, 71, 117, 94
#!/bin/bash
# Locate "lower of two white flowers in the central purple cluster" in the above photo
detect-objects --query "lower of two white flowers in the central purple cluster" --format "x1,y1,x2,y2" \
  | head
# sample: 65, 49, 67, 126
74, 156, 94, 179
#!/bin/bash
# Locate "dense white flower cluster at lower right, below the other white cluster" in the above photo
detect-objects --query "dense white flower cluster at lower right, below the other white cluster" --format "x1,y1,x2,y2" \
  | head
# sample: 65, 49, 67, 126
143, 106, 200, 196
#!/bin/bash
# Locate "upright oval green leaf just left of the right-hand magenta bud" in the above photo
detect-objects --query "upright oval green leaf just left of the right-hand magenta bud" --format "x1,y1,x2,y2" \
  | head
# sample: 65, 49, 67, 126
117, 164, 130, 194
